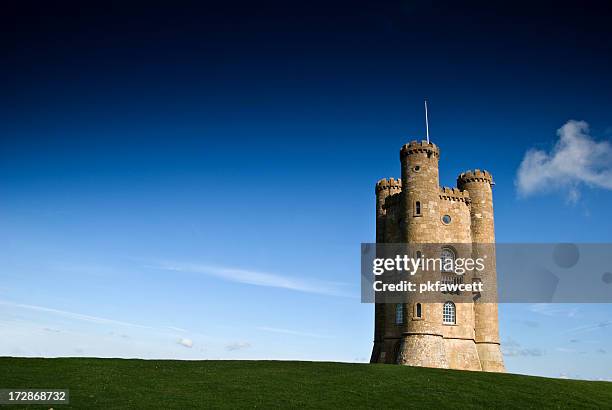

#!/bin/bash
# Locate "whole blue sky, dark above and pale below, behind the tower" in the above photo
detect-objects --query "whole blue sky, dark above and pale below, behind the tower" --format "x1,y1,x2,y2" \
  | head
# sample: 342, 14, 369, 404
0, 2, 612, 379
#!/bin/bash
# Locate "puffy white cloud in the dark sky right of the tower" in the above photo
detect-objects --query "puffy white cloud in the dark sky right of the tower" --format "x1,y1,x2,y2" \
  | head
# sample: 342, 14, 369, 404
515, 120, 612, 203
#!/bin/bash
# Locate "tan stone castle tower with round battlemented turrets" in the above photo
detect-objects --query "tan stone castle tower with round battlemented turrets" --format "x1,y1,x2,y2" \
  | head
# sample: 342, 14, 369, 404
370, 141, 505, 372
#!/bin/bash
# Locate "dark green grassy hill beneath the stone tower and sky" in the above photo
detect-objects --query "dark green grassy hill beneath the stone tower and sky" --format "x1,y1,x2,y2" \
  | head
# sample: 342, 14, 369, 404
0, 357, 612, 409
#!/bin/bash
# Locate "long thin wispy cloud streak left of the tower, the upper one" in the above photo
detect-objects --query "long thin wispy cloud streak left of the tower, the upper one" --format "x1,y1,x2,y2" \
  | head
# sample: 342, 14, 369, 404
152, 263, 355, 297
